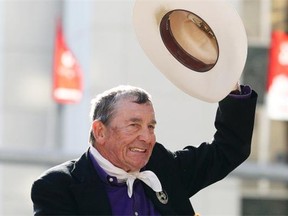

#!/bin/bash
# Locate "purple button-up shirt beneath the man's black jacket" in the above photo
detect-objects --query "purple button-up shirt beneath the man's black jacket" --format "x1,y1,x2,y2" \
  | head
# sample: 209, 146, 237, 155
90, 150, 160, 216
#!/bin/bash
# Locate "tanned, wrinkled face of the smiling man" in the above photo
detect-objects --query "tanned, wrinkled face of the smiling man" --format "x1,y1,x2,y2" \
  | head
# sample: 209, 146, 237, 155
98, 100, 156, 172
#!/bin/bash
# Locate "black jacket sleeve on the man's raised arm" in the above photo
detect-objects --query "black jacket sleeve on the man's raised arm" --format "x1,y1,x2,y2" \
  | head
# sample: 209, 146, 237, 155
175, 91, 257, 197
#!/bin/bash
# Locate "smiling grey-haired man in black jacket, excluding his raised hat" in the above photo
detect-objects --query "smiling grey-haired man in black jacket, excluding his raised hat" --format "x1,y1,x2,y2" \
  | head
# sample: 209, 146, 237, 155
32, 86, 257, 215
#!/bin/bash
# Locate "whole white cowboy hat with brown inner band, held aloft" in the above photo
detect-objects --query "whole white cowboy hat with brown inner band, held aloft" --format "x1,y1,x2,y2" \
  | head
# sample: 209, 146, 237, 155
133, 0, 247, 102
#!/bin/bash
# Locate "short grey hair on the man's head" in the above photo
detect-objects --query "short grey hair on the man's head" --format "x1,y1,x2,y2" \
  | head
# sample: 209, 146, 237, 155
89, 85, 152, 144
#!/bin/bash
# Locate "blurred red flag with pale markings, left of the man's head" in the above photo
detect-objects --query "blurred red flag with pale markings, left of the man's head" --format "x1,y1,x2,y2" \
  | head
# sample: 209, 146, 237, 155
53, 22, 82, 104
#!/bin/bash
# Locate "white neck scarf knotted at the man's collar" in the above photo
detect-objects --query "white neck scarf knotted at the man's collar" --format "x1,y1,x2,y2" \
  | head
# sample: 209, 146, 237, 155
90, 146, 162, 198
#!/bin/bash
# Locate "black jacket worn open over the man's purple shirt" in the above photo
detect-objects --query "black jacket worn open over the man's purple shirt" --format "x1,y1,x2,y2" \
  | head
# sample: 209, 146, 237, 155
31, 92, 257, 215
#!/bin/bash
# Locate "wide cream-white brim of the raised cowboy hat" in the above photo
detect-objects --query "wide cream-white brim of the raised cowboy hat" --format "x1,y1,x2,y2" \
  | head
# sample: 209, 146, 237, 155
133, 0, 247, 102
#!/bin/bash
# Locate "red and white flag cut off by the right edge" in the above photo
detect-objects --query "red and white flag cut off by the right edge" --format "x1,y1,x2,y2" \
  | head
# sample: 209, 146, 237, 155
267, 31, 288, 120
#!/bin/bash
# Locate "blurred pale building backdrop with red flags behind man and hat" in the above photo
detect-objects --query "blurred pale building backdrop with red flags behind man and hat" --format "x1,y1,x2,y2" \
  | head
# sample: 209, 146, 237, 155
0, 0, 288, 216
